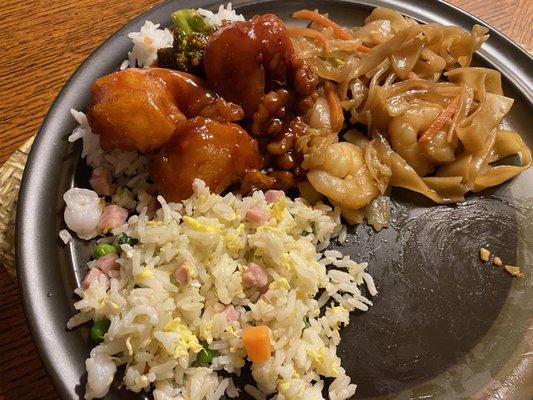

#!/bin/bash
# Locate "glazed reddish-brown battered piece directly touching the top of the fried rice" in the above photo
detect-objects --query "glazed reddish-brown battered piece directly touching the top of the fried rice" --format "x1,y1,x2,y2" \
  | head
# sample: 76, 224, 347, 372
150, 117, 262, 201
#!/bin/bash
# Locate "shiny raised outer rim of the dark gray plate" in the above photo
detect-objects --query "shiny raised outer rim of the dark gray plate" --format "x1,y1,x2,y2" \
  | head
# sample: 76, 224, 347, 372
16, 0, 533, 399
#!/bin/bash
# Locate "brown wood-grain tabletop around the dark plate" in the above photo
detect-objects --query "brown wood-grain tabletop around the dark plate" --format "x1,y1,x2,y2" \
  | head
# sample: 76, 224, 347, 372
0, 0, 533, 400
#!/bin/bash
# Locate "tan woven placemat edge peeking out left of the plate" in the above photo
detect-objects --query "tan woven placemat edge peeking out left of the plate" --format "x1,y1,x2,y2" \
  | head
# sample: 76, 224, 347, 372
0, 136, 35, 276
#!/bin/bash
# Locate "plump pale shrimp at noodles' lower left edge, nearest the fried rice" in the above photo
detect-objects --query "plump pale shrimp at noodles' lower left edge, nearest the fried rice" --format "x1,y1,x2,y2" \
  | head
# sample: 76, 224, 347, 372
302, 142, 380, 210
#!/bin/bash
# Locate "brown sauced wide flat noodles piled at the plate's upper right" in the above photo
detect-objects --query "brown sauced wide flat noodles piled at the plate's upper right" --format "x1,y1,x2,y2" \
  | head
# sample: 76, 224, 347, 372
292, 7, 531, 226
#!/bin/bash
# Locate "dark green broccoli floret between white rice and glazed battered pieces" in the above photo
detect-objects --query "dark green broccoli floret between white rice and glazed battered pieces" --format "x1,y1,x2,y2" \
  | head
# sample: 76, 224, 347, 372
157, 9, 214, 75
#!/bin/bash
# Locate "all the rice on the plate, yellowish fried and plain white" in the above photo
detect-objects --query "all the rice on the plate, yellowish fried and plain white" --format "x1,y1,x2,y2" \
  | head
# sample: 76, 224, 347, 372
61, 4, 377, 400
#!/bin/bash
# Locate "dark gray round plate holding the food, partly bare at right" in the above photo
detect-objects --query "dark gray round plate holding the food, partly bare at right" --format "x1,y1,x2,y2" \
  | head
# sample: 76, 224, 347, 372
17, 0, 533, 400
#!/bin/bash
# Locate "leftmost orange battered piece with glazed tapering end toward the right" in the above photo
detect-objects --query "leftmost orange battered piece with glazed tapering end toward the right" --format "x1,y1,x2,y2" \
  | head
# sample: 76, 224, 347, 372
87, 68, 243, 153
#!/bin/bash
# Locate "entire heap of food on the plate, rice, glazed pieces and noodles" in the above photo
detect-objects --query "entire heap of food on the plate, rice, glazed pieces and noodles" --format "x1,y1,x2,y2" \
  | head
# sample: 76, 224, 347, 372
59, 4, 531, 400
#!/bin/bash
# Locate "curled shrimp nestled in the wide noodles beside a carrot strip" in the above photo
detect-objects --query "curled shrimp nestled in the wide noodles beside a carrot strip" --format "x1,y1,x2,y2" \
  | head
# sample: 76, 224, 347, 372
389, 102, 456, 176
